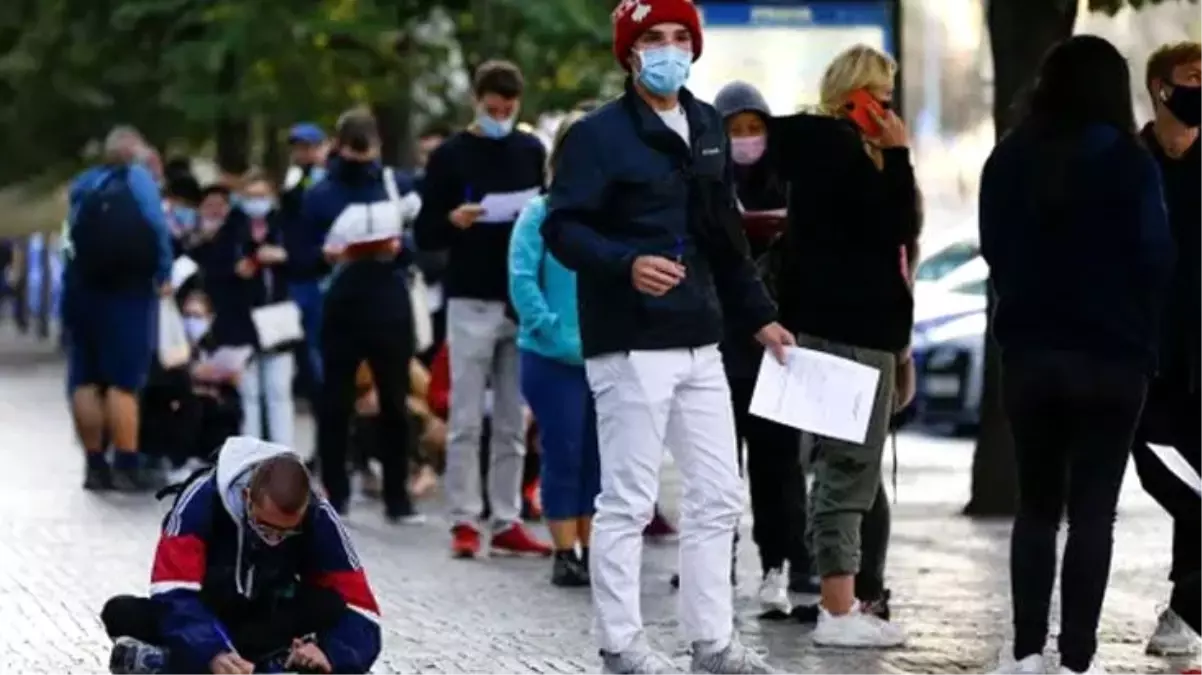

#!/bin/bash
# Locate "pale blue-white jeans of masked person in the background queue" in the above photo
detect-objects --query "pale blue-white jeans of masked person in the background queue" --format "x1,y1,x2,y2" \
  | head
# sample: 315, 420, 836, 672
238, 352, 296, 448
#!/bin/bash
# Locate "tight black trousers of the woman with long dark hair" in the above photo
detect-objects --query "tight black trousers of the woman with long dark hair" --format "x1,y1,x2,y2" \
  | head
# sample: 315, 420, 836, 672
1002, 352, 1148, 671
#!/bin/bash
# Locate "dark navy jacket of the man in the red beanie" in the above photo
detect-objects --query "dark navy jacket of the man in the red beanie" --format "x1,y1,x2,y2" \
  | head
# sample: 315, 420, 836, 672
542, 82, 775, 357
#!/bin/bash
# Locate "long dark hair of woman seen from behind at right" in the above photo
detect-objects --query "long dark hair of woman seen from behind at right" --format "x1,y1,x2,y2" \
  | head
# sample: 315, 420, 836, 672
1017, 35, 1139, 219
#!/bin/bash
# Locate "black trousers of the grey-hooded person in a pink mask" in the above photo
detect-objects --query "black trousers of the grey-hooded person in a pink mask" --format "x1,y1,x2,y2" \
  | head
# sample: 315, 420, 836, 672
730, 377, 810, 573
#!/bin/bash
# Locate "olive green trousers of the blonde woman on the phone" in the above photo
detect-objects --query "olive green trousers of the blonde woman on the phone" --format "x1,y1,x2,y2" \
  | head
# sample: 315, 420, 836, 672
797, 334, 897, 578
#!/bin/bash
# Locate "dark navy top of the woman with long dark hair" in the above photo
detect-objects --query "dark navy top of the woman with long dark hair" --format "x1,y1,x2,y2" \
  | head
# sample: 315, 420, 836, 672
980, 125, 1174, 374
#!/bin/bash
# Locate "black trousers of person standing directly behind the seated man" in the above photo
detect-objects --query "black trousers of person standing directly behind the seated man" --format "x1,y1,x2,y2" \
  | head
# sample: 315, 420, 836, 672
317, 312, 413, 516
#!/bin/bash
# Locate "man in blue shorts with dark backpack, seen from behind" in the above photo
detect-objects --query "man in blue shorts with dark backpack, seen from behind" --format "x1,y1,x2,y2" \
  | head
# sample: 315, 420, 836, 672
63, 127, 172, 491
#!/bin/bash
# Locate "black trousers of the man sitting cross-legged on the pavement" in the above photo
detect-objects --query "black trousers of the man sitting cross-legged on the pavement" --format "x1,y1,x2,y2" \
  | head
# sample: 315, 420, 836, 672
100, 586, 346, 662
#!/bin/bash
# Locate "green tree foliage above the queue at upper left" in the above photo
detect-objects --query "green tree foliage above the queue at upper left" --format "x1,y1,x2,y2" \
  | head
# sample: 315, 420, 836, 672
0, 0, 614, 185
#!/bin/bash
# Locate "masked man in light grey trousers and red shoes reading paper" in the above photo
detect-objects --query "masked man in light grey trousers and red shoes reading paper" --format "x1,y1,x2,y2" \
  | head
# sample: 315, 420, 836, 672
415, 61, 552, 557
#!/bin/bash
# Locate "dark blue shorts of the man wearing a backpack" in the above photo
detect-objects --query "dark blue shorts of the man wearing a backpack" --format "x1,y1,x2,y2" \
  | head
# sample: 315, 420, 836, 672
63, 286, 159, 393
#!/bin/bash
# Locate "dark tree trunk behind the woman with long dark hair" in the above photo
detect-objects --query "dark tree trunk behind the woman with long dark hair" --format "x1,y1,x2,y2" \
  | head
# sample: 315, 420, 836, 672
964, 0, 1077, 516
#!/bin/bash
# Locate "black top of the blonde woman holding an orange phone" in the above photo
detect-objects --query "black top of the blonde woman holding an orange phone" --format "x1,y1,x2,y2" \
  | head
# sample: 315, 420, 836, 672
768, 114, 921, 352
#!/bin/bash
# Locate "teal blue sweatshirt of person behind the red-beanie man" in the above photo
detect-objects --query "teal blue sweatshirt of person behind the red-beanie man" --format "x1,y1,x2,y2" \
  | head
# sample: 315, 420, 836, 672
510, 197, 584, 364
